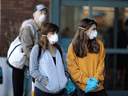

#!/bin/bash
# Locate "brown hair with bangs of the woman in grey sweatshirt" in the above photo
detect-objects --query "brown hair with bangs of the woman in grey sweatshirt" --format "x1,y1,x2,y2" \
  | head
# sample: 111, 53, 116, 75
37, 23, 62, 55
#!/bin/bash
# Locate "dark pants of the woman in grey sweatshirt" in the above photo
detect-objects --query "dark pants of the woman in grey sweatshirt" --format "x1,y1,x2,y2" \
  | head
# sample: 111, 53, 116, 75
34, 87, 64, 96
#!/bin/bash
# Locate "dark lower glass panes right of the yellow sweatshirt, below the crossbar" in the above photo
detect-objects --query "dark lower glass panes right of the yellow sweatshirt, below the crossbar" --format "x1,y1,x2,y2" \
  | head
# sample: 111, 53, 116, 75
104, 54, 128, 90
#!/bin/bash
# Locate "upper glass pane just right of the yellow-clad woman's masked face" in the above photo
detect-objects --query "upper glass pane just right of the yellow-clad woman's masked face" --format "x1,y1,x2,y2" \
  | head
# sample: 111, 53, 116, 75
92, 7, 115, 48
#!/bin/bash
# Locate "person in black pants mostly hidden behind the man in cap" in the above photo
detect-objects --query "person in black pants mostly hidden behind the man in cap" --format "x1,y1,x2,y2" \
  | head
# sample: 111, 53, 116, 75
12, 19, 33, 96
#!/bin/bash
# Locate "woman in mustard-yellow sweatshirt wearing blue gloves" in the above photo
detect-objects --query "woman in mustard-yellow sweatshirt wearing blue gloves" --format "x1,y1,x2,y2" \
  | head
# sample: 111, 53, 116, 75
68, 18, 107, 96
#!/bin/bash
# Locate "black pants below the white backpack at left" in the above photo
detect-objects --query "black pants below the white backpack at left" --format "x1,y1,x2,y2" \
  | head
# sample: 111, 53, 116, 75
12, 68, 24, 96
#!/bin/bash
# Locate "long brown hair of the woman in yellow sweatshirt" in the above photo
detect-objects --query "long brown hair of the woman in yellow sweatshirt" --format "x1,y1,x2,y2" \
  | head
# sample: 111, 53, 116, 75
72, 18, 100, 58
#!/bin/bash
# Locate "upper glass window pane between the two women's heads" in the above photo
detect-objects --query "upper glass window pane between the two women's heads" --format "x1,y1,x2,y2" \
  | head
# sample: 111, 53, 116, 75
60, 6, 89, 52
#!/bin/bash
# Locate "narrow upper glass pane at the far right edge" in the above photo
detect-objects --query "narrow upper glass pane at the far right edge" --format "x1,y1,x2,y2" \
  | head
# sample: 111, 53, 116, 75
117, 8, 128, 49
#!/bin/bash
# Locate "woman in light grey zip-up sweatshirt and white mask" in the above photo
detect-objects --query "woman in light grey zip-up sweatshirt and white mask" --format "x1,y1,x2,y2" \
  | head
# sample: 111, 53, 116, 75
29, 23, 68, 96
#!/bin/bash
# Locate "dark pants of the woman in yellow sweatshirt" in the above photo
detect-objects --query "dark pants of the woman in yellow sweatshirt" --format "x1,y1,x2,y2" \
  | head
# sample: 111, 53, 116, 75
81, 89, 108, 96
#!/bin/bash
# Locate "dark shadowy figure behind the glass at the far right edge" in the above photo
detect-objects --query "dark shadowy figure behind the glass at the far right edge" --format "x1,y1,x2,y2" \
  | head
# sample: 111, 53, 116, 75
117, 19, 128, 90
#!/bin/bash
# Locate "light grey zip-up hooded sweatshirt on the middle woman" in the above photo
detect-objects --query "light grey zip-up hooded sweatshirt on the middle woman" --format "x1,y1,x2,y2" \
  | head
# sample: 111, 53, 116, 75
29, 45, 67, 94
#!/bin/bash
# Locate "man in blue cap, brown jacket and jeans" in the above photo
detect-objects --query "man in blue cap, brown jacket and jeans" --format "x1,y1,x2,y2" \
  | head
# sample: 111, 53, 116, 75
19, 4, 48, 96
